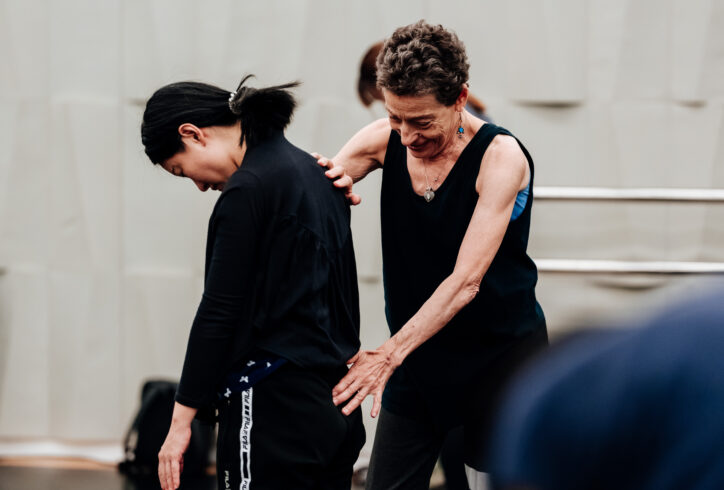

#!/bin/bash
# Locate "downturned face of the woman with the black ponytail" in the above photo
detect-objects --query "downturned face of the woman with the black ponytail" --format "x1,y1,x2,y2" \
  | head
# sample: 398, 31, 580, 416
161, 124, 246, 192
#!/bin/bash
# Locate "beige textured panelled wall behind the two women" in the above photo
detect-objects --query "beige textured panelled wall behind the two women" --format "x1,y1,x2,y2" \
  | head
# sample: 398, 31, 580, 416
0, 0, 724, 440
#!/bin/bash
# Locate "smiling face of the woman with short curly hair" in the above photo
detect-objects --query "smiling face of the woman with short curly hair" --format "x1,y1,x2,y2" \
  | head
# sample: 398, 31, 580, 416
382, 89, 465, 159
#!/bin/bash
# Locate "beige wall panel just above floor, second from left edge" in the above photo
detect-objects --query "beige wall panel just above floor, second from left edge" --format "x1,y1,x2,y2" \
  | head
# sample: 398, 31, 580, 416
46, 268, 120, 440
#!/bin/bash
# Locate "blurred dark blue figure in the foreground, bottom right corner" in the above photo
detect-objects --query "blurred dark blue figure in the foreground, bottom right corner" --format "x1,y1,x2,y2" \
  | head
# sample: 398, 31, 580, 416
492, 288, 724, 490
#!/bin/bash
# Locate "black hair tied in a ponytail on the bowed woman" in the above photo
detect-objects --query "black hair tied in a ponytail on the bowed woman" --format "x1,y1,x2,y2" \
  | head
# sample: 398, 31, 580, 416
141, 75, 299, 164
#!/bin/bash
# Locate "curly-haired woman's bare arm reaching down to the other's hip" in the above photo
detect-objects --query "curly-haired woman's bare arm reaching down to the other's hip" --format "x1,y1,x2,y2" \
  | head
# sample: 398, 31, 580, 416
332, 136, 528, 417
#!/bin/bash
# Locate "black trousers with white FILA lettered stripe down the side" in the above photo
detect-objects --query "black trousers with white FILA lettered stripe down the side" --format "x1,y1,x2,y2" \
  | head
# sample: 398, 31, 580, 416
216, 363, 365, 490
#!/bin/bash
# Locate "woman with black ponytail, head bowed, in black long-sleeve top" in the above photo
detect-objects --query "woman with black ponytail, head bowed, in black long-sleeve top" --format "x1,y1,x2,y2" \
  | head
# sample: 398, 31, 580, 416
141, 77, 364, 490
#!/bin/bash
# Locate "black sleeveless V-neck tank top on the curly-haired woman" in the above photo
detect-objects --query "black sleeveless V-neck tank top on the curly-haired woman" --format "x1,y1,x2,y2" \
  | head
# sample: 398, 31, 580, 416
381, 124, 545, 422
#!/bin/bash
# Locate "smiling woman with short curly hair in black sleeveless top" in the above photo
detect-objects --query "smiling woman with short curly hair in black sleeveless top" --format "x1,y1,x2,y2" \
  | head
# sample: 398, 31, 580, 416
320, 21, 547, 490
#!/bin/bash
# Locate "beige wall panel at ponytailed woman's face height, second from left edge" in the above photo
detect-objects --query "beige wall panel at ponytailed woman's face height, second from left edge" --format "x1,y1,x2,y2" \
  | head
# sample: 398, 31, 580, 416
50, 103, 122, 272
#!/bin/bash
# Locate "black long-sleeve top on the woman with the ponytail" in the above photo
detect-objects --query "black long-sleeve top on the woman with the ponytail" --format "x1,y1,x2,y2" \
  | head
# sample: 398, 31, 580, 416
176, 133, 360, 408
